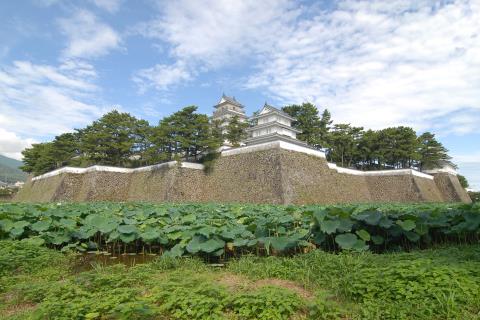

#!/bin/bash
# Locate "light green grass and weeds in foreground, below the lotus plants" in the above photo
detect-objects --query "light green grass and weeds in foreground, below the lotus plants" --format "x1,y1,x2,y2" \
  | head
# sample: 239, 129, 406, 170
0, 241, 480, 319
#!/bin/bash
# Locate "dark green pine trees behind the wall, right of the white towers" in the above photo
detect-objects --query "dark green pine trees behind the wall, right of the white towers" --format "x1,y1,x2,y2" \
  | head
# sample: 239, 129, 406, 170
282, 103, 453, 170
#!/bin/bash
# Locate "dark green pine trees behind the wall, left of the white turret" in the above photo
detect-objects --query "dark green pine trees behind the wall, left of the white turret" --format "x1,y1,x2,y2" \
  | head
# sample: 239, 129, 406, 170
22, 106, 245, 175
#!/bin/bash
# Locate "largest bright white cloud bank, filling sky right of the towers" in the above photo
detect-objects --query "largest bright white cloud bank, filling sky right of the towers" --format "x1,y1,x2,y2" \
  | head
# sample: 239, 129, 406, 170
247, 1, 480, 133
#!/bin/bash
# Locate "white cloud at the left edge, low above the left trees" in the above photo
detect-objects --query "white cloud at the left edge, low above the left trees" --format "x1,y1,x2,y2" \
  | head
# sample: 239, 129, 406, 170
0, 60, 104, 156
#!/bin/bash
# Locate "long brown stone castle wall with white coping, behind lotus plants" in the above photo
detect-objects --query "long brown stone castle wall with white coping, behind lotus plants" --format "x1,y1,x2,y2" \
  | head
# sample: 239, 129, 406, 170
15, 142, 470, 204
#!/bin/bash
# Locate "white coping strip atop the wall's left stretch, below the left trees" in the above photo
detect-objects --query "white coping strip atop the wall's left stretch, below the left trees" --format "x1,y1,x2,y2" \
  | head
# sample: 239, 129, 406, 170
32, 161, 204, 181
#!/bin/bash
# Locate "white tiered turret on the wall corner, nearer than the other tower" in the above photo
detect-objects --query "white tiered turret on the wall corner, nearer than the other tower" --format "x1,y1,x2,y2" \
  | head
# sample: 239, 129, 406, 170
245, 103, 307, 146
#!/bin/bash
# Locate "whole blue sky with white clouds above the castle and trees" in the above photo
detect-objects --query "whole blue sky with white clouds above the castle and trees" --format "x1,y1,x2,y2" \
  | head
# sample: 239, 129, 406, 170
0, 0, 480, 189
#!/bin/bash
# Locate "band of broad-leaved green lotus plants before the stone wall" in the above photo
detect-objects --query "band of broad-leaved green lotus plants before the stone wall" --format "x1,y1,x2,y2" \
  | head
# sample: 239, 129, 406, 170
0, 203, 480, 257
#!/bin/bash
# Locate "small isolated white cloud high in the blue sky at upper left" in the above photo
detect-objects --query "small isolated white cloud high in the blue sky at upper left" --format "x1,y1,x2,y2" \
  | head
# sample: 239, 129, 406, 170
58, 10, 121, 58
